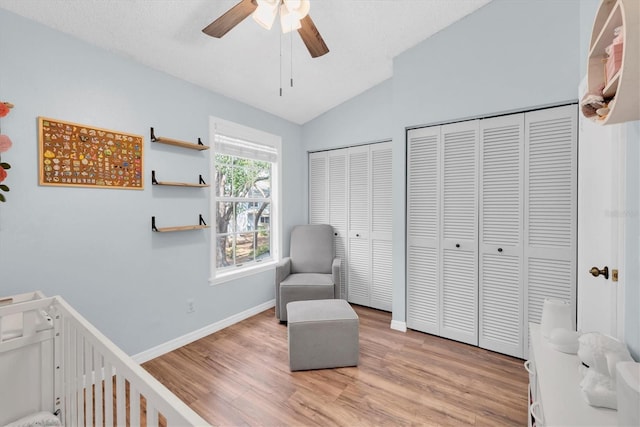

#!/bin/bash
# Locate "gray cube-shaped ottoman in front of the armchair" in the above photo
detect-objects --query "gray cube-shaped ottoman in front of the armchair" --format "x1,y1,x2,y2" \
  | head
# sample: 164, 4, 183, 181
287, 299, 360, 371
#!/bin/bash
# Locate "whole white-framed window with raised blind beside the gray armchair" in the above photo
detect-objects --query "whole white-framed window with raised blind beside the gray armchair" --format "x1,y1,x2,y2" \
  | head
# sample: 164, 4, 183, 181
211, 119, 280, 282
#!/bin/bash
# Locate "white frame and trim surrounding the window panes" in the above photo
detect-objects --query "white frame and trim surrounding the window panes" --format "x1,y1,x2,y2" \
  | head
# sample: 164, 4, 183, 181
209, 116, 282, 285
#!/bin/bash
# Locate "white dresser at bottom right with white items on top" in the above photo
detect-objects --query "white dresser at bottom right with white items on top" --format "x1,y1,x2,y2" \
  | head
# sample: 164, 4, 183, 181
525, 323, 618, 427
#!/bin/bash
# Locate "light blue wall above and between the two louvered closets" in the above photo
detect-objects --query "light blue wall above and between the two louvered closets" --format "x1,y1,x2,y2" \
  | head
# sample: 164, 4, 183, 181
303, 0, 586, 328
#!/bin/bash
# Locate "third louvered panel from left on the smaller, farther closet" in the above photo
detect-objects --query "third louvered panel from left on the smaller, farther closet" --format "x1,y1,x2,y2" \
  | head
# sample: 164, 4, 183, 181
347, 146, 371, 306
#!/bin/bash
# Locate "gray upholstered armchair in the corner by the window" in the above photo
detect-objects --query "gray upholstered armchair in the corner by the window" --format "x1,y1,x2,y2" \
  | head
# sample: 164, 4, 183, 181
276, 224, 341, 322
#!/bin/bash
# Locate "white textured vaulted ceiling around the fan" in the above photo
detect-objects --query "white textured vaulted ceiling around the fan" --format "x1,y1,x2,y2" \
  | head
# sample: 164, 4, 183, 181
0, 0, 490, 124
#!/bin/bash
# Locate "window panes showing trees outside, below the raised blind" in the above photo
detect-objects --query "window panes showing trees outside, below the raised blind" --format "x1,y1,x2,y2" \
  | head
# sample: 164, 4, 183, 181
215, 154, 272, 269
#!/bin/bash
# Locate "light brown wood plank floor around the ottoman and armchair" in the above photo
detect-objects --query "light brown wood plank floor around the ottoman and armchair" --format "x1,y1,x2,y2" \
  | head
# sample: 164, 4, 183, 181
143, 306, 528, 426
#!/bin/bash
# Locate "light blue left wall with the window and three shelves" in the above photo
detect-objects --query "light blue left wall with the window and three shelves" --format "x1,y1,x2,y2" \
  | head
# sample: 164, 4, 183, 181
0, 10, 306, 354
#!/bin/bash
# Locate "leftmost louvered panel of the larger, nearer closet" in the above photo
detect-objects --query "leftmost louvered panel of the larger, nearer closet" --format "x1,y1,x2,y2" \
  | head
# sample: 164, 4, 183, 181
407, 126, 440, 335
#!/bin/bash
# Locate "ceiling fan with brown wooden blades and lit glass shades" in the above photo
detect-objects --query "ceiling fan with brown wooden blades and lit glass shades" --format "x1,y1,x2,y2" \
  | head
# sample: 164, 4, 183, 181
202, 0, 329, 58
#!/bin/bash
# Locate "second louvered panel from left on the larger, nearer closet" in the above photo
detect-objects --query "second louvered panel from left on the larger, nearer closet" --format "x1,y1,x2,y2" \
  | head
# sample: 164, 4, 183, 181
440, 120, 478, 345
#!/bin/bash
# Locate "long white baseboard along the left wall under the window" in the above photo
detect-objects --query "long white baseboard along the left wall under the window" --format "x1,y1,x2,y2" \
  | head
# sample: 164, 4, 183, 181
131, 299, 276, 364
